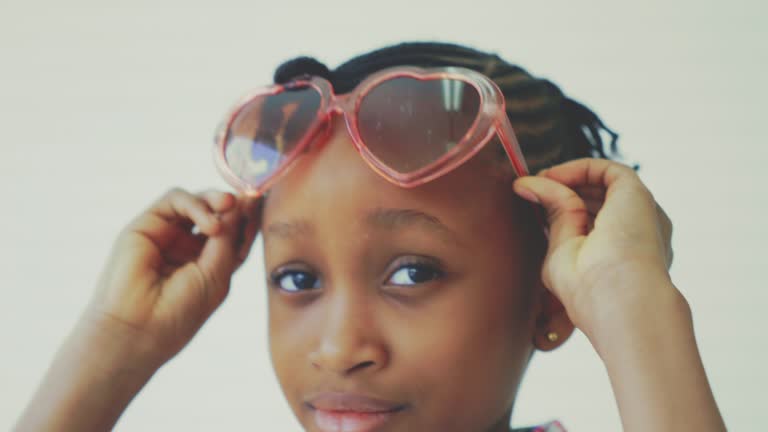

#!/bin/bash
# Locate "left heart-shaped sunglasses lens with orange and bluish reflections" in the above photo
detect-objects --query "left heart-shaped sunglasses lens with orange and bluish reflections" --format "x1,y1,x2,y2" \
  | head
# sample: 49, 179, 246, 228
224, 86, 321, 186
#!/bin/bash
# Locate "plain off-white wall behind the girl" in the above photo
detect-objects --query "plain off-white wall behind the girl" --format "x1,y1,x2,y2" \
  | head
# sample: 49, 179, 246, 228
0, 0, 768, 431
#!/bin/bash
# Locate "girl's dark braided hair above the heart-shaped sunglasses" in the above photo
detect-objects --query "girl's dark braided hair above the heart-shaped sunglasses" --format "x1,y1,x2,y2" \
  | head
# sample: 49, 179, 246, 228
275, 42, 618, 173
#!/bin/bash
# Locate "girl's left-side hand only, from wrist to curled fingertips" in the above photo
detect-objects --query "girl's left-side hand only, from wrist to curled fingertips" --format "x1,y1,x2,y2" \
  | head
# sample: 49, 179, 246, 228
83, 188, 260, 368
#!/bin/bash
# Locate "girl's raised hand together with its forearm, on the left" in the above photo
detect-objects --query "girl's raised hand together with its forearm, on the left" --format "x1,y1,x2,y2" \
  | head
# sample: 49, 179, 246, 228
14, 189, 260, 432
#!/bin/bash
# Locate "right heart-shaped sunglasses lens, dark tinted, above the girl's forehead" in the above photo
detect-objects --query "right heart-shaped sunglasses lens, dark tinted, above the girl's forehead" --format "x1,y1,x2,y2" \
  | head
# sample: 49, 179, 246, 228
358, 77, 480, 173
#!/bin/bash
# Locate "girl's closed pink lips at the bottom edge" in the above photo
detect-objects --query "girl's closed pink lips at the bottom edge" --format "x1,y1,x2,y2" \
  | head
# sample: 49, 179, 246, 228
306, 393, 406, 432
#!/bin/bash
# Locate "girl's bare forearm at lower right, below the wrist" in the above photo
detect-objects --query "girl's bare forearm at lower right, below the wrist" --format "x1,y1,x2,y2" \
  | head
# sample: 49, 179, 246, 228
591, 281, 725, 432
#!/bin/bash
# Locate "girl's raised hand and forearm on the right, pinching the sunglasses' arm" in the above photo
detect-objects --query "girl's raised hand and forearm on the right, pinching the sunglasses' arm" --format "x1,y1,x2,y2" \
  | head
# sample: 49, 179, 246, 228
514, 159, 725, 431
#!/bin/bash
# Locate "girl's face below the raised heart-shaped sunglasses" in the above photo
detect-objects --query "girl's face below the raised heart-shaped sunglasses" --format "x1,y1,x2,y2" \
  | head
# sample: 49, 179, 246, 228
263, 118, 542, 431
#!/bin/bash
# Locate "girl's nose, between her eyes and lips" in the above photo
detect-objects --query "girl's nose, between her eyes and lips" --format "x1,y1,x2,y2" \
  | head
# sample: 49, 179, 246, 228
309, 294, 389, 376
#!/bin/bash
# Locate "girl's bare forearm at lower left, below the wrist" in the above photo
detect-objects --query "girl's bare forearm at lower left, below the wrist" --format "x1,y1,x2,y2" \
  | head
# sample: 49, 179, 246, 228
15, 314, 156, 432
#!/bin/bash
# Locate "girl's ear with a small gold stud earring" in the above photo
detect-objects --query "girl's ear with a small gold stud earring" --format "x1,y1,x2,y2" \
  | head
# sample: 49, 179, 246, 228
533, 282, 574, 351
